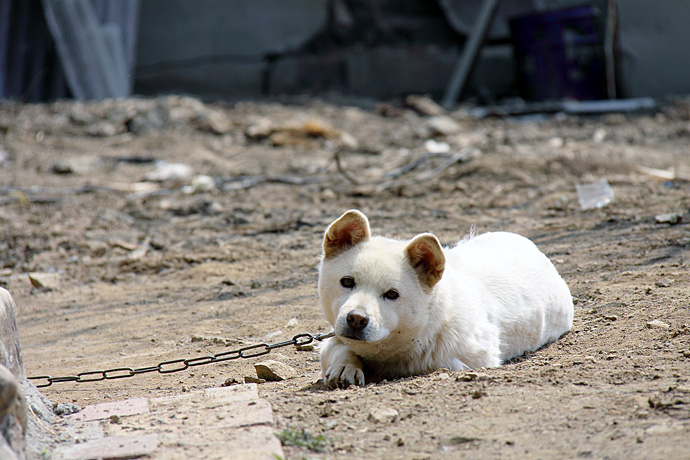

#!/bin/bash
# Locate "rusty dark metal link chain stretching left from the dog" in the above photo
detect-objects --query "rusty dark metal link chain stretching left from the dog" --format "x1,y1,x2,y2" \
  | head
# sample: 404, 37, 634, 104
29, 331, 335, 388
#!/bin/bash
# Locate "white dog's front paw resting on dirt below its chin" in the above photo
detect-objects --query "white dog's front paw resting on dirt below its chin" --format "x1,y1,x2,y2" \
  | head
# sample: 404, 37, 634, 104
320, 337, 364, 388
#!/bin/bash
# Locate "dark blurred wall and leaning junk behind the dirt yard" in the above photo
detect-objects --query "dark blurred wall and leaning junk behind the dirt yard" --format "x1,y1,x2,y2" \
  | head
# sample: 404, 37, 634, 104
0, 0, 690, 104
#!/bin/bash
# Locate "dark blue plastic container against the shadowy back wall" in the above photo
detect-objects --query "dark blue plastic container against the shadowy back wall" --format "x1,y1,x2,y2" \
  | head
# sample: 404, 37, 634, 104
510, 5, 608, 101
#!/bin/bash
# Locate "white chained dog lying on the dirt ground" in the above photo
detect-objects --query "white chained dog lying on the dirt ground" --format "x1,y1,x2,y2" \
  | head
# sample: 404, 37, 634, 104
319, 210, 573, 387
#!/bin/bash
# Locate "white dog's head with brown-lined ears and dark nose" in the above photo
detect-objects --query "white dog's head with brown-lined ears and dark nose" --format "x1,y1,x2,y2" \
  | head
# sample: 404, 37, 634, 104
319, 210, 445, 358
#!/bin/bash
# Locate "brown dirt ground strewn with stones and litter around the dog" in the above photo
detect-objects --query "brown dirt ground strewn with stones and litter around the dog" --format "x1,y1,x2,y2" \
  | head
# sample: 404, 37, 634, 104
0, 97, 690, 459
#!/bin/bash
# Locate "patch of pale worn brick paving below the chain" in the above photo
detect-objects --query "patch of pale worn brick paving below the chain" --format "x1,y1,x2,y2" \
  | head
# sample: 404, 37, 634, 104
56, 384, 284, 460
